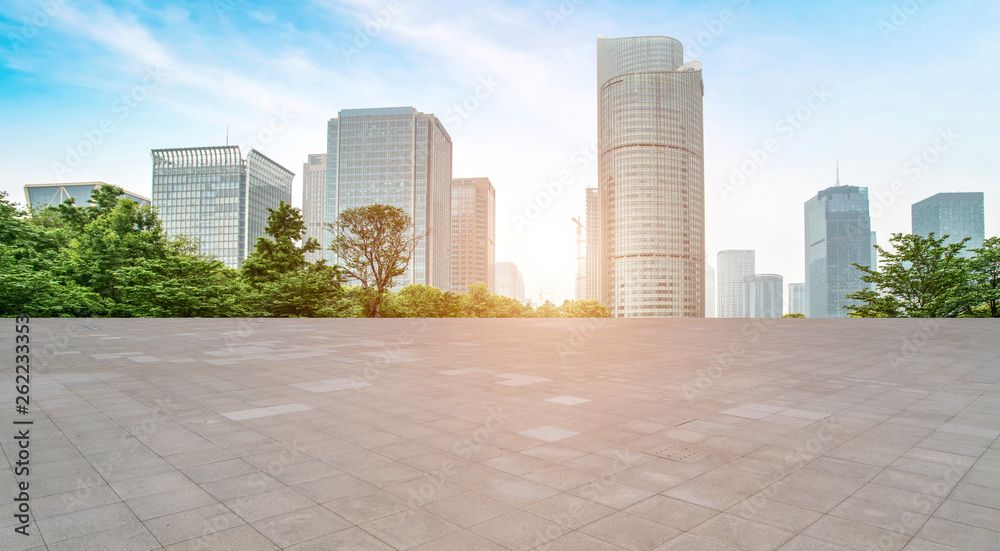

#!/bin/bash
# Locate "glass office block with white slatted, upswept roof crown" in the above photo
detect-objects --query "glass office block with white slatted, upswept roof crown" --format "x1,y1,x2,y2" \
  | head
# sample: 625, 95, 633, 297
150, 145, 295, 268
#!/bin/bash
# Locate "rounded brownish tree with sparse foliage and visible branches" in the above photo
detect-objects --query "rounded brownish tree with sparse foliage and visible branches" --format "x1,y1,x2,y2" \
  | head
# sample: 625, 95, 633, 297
327, 204, 422, 318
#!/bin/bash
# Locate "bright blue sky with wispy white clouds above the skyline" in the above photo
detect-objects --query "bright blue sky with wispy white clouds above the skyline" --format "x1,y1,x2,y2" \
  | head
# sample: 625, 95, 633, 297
0, 0, 1000, 303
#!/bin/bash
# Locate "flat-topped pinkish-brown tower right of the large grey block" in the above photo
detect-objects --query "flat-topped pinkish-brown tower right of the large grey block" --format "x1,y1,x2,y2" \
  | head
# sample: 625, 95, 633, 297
451, 178, 496, 293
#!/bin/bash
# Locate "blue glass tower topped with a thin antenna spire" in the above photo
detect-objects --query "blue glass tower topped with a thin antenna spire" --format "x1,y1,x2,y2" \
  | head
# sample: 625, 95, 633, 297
802, 183, 873, 318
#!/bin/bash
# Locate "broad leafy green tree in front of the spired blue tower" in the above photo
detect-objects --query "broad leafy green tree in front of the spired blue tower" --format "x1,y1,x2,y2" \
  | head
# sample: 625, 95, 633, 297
847, 233, 974, 318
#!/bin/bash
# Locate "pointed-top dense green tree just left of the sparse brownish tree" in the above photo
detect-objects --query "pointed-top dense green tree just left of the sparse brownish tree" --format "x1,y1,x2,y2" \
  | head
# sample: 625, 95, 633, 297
241, 201, 349, 317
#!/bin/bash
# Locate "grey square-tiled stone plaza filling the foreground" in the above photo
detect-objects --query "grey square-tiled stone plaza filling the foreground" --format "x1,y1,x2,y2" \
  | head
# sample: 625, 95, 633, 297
0, 319, 1000, 551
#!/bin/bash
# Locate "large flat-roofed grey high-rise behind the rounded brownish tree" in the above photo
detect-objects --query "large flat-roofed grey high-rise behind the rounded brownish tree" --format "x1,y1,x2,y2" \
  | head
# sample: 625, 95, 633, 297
322, 107, 451, 291
